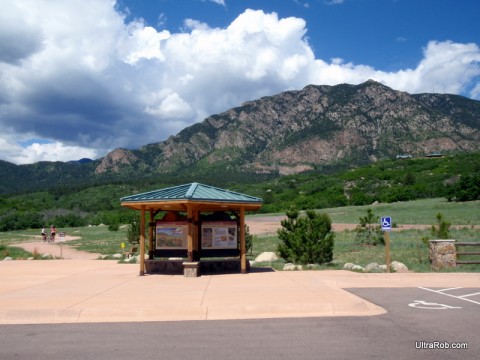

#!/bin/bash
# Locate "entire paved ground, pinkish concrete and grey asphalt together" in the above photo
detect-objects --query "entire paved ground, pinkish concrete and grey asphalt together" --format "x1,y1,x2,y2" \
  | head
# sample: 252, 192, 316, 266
0, 260, 480, 360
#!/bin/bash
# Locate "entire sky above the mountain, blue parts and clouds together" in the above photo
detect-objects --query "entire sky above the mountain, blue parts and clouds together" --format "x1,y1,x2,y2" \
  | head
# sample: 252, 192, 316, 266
0, 0, 480, 164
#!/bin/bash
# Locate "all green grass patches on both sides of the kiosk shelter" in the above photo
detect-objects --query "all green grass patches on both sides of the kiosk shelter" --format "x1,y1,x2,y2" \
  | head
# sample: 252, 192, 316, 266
0, 199, 480, 272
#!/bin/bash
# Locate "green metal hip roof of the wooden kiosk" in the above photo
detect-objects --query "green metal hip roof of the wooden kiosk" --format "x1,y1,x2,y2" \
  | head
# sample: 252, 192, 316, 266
120, 183, 263, 204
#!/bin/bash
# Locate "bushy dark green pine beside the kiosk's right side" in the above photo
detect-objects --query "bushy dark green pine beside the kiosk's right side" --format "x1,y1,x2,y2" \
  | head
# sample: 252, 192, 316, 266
278, 209, 334, 264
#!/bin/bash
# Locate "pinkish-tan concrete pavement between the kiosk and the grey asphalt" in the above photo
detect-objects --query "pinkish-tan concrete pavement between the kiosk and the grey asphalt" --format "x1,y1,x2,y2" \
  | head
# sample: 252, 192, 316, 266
0, 260, 480, 324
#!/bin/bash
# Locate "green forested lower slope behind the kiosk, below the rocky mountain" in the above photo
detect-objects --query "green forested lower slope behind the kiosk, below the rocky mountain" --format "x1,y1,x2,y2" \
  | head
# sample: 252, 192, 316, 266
0, 153, 480, 231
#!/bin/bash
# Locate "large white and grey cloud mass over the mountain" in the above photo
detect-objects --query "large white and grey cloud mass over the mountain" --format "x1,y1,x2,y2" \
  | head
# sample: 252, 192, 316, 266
0, 0, 480, 163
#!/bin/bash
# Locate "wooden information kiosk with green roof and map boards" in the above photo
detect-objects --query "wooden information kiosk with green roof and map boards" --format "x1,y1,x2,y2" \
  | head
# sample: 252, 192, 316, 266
120, 183, 263, 276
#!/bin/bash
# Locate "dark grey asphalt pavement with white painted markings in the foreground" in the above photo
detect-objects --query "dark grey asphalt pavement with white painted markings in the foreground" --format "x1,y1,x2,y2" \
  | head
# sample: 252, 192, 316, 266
0, 288, 480, 360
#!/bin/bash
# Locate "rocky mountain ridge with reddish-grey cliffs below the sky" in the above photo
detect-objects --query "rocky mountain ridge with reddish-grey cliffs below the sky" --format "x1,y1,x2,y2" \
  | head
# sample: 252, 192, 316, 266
0, 80, 480, 193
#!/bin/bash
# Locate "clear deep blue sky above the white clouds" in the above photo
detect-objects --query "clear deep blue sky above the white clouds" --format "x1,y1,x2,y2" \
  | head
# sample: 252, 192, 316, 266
119, 0, 480, 71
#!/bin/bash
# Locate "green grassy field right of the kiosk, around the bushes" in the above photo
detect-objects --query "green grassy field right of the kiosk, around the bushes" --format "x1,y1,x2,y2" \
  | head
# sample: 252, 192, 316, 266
250, 199, 480, 272
